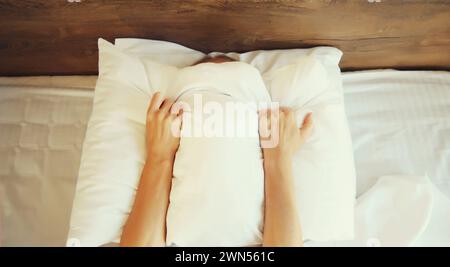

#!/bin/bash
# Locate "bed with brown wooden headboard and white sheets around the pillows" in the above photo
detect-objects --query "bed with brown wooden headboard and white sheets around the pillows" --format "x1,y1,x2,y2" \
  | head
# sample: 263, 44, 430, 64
0, 0, 450, 246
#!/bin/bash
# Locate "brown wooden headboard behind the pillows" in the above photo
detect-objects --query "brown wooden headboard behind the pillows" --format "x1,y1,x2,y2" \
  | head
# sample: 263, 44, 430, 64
0, 0, 450, 75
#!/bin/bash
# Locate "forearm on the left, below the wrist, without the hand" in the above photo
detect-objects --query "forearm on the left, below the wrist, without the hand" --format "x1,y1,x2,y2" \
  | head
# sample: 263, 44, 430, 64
120, 161, 173, 246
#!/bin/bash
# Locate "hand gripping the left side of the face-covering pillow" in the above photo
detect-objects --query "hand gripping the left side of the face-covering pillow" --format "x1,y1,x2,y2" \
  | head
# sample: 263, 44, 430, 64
146, 92, 182, 164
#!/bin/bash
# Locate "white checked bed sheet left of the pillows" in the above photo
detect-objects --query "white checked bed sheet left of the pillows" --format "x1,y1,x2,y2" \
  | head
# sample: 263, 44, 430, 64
0, 77, 96, 246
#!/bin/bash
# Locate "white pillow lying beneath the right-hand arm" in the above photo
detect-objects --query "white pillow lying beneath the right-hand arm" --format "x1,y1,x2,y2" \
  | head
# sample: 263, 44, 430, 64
264, 56, 356, 241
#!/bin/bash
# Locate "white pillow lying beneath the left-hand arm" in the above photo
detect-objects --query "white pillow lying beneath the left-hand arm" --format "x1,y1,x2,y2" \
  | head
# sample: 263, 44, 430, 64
67, 39, 152, 246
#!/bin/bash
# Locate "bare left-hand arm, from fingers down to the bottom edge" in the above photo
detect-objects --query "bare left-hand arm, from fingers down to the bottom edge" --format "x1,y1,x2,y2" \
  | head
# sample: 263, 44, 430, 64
120, 93, 181, 246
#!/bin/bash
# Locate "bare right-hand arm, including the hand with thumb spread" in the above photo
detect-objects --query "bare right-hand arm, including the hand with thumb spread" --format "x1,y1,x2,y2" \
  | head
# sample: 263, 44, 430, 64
260, 109, 312, 247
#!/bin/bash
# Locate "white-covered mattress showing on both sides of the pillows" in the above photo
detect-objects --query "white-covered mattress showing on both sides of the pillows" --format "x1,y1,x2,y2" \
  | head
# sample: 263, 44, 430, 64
0, 70, 450, 246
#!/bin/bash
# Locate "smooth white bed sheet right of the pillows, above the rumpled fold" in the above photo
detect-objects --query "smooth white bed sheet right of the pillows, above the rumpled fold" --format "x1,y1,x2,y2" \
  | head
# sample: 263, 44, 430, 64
342, 70, 450, 246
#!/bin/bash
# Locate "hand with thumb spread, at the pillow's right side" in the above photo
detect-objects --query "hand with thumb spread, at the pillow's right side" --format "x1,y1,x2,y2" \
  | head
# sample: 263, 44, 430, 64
259, 108, 312, 163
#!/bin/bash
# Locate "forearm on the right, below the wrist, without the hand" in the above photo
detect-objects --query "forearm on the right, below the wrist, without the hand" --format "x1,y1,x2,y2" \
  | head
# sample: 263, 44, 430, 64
263, 159, 303, 246
